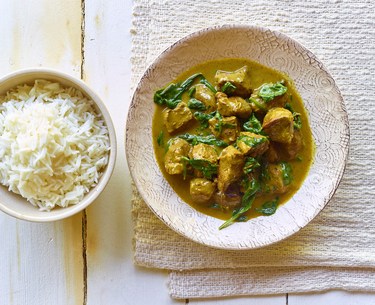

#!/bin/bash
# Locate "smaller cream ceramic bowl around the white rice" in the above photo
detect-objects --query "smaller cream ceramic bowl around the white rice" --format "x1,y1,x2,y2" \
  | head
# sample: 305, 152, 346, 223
0, 68, 116, 222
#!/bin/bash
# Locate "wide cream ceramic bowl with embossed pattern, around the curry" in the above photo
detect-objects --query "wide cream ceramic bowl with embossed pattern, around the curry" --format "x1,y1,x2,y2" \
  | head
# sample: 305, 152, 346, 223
126, 26, 349, 249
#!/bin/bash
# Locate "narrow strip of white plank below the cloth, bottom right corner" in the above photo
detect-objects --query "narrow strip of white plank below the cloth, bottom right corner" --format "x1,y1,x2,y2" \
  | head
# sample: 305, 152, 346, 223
288, 290, 375, 305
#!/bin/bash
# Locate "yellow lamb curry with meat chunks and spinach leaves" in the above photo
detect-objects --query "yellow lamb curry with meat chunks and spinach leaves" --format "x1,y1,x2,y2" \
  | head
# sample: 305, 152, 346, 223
152, 59, 313, 229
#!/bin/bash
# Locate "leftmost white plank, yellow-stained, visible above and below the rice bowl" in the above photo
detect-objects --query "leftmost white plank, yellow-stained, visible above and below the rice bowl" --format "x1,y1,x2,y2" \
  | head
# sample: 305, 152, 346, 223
0, 0, 84, 305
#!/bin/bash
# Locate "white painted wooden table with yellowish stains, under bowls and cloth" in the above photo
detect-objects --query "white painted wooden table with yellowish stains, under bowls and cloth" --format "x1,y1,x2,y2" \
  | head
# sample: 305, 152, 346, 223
0, 0, 375, 305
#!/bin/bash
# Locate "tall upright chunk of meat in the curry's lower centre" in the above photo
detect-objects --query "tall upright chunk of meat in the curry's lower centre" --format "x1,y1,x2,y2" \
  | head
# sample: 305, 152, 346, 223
218, 145, 245, 192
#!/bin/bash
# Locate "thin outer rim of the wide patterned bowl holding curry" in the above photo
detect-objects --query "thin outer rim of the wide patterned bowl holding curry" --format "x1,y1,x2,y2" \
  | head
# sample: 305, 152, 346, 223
125, 24, 350, 250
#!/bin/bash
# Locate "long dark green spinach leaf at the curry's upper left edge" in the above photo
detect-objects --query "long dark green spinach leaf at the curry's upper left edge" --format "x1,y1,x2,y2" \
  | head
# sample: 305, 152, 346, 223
154, 73, 203, 109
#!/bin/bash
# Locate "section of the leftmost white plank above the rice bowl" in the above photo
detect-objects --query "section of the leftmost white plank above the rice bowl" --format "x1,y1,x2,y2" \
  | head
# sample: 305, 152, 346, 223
0, 0, 81, 76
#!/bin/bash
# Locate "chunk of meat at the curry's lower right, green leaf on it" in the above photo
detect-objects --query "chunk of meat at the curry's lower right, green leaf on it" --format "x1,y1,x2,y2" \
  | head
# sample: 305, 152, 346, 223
262, 162, 292, 194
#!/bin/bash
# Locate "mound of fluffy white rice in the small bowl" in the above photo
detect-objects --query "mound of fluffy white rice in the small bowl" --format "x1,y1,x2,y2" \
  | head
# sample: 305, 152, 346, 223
0, 80, 110, 211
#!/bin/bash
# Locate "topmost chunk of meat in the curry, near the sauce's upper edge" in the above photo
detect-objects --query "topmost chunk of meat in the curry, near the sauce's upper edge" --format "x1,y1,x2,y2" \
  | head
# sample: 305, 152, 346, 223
215, 66, 251, 98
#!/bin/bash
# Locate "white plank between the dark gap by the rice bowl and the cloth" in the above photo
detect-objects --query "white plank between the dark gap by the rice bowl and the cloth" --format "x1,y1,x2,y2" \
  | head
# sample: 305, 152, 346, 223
84, 0, 185, 305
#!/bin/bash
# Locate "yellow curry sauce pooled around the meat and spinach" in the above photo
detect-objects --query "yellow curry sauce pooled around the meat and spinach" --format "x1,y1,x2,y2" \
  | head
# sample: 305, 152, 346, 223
152, 58, 314, 227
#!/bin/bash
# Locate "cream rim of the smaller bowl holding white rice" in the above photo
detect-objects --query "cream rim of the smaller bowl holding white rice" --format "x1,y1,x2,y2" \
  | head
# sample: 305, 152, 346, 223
0, 67, 117, 223
